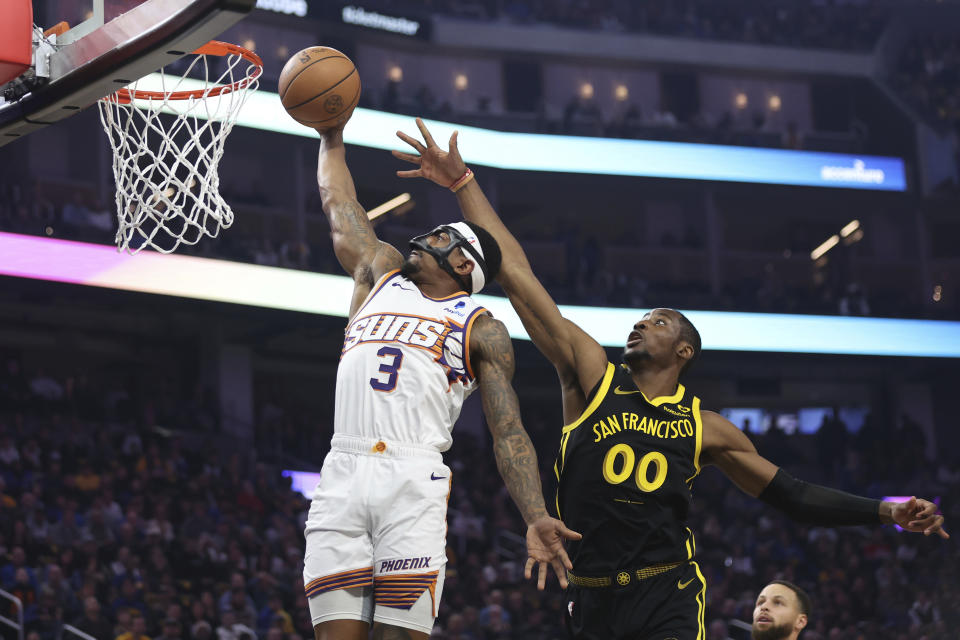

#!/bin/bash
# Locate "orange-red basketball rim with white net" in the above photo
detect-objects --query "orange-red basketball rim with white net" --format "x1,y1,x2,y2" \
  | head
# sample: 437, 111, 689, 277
98, 40, 263, 254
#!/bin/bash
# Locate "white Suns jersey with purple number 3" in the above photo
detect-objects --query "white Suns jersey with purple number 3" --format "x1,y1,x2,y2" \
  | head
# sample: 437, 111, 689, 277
334, 271, 486, 451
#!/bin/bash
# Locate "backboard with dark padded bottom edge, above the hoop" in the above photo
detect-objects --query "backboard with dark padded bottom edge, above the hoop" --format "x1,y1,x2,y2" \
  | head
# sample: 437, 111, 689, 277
0, 0, 256, 146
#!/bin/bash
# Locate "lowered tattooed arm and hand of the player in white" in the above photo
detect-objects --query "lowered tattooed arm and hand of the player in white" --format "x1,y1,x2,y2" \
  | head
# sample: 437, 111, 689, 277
469, 315, 580, 589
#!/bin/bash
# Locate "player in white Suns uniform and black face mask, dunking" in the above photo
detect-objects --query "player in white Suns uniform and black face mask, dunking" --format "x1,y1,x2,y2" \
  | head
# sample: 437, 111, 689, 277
303, 129, 579, 640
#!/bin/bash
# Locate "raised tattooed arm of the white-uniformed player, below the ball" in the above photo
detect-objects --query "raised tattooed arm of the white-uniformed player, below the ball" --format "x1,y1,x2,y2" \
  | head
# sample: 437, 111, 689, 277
317, 128, 403, 316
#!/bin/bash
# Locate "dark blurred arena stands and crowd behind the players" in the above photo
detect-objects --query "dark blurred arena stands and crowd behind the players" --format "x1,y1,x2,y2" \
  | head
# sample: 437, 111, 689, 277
0, 0, 960, 640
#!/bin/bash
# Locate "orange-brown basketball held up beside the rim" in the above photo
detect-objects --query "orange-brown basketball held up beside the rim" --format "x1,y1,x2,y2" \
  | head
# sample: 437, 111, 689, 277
277, 47, 360, 131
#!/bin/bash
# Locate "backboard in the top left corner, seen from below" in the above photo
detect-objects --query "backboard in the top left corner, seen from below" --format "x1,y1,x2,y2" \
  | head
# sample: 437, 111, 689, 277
0, 0, 256, 146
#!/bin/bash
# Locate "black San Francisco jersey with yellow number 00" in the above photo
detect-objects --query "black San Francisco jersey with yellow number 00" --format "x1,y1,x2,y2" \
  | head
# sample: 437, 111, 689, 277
554, 363, 703, 574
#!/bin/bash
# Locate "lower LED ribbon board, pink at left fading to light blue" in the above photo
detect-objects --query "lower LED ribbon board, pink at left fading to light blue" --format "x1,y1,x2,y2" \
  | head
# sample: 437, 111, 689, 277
0, 230, 960, 358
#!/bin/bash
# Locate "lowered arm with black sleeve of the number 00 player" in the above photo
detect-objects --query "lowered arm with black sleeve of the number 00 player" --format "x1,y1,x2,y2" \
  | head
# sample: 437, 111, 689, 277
702, 411, 950, 538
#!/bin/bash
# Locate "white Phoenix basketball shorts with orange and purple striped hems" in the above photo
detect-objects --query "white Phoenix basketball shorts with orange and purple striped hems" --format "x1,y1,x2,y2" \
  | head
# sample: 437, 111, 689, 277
303, 435, 451, 633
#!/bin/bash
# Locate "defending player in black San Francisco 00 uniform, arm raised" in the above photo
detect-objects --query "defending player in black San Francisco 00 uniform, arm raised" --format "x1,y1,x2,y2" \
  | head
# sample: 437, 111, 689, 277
393, 119, 947, 640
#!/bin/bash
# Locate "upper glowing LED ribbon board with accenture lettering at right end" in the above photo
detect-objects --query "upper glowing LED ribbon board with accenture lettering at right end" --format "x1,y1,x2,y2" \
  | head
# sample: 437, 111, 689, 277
129, 73, 907, 191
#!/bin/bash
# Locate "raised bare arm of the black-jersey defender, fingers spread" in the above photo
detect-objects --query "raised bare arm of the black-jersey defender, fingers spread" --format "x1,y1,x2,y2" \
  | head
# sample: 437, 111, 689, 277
393, 118, 607, 394
